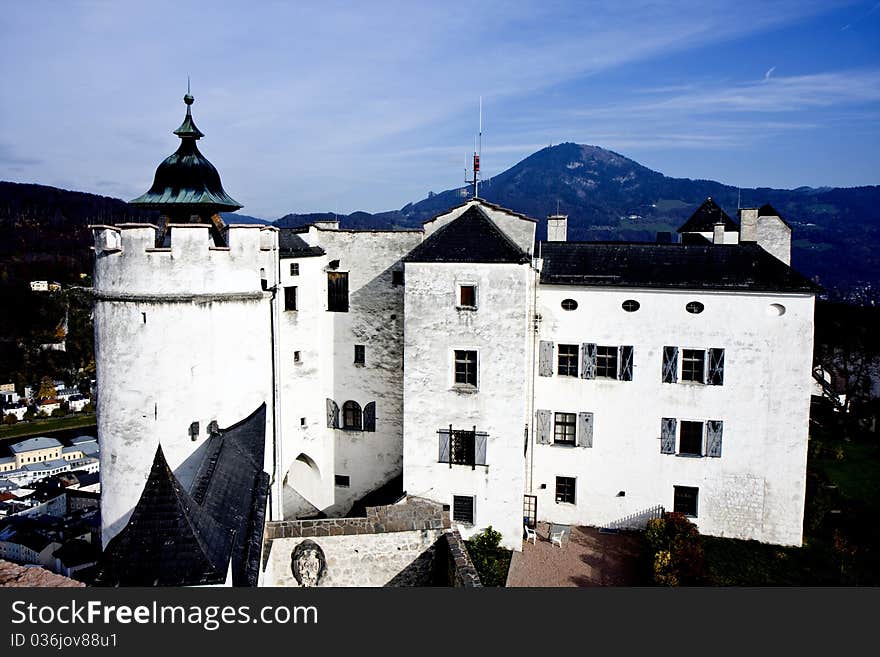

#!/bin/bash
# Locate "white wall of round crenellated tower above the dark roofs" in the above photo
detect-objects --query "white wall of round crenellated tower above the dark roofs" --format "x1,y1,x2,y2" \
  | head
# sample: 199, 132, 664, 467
94, 225, 277, 545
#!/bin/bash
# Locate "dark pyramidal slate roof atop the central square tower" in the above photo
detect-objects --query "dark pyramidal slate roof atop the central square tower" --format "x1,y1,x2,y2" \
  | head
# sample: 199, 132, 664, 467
403, 205, 530, 263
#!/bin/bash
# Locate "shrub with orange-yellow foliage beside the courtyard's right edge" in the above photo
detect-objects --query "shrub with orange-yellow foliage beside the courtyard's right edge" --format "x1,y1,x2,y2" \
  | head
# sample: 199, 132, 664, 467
645, 513, 706, 586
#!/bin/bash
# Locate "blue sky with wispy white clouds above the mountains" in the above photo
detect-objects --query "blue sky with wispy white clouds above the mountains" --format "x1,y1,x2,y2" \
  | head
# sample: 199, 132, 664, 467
0, 0, 880, 218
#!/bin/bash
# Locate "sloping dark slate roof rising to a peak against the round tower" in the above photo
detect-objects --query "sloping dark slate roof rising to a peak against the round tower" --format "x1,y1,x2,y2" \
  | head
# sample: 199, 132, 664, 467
192, 404, 269, 586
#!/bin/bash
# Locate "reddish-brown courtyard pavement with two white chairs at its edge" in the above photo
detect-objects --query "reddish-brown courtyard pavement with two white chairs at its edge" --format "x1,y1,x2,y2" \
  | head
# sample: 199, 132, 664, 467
507, 522, 648, 587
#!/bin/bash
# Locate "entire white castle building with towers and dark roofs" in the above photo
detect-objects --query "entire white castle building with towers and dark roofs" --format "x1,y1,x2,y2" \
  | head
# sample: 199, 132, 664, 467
93, 94, 818, 585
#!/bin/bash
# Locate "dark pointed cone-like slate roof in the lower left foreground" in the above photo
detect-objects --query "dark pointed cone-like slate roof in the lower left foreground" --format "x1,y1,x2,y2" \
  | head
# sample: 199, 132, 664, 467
95, 446, 234, 586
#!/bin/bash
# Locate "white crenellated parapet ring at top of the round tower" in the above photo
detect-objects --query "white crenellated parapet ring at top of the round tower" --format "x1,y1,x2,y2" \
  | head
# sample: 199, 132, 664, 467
91, 224, 278, 301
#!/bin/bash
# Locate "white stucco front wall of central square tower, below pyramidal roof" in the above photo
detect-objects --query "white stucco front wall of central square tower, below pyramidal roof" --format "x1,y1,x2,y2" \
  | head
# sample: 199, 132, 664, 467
403, 263, 534, 550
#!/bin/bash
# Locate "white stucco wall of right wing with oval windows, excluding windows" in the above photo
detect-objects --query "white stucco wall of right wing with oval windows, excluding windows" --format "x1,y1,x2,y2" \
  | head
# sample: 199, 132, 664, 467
530, 285, 813, 545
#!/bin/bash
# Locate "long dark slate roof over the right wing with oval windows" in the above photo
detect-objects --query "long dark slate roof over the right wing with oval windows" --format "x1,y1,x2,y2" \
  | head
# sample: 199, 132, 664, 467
540, 242, 821, 293
